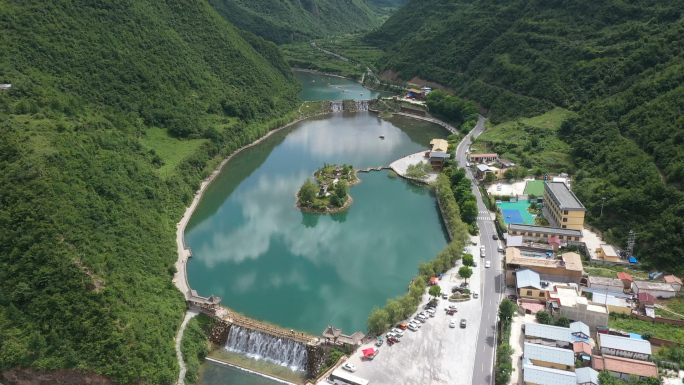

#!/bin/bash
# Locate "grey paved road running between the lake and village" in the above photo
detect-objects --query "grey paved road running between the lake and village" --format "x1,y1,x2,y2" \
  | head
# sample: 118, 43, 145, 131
456, 117, 504, 385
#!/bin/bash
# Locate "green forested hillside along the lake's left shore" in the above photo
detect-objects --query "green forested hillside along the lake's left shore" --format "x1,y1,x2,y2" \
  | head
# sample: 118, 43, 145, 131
0, 0, 299, 384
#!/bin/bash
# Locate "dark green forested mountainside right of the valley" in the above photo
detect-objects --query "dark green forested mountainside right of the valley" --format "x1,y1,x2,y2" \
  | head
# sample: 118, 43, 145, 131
368, 0, 684, 271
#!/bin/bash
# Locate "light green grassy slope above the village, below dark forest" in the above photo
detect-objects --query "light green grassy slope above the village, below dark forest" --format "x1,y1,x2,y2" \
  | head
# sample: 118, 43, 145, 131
474, 108, 574, 171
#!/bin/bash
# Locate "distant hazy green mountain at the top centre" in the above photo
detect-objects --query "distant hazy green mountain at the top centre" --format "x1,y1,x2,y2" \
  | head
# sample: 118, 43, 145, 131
209, 0, 382, 44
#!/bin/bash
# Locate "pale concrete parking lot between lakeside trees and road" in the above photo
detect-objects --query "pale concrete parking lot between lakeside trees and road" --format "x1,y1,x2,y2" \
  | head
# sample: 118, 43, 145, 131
320, 237, 485, 385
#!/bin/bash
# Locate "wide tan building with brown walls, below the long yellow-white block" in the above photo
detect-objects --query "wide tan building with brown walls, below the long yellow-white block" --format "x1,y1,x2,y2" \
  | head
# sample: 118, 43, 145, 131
506, 247, 583, 285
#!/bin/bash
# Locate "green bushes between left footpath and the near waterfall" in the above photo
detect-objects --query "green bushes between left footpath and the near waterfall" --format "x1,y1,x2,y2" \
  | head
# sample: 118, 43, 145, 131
181, 313, 213, 384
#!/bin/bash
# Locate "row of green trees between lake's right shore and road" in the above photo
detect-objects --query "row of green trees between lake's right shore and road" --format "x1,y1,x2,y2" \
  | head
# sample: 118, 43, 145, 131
366, 173, 468, 334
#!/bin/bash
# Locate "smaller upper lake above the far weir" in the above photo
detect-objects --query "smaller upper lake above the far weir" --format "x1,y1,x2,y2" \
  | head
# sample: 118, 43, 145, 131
295, 71, 394, 101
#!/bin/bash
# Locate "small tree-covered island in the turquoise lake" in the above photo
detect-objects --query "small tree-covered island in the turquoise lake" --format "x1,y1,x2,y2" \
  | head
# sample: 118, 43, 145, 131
297, 164, 360, 213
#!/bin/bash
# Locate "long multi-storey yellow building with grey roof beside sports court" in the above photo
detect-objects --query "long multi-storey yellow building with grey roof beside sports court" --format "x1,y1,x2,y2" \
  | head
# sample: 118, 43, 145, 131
543, 182, 587, 230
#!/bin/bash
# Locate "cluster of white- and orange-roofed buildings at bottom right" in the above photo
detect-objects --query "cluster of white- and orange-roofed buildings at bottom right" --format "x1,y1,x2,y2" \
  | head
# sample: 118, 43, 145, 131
521, 322, 658, 385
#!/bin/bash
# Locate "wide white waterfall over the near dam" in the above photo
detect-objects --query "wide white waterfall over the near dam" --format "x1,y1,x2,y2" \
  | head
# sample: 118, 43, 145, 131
224, 325, 308, 371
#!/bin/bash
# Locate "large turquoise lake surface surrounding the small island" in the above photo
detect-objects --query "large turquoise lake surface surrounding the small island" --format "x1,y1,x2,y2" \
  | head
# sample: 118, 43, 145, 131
185, 112, 447, 335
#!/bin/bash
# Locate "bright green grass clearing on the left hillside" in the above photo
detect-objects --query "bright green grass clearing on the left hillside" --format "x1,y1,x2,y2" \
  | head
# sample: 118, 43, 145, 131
140, 127, 207, 179
